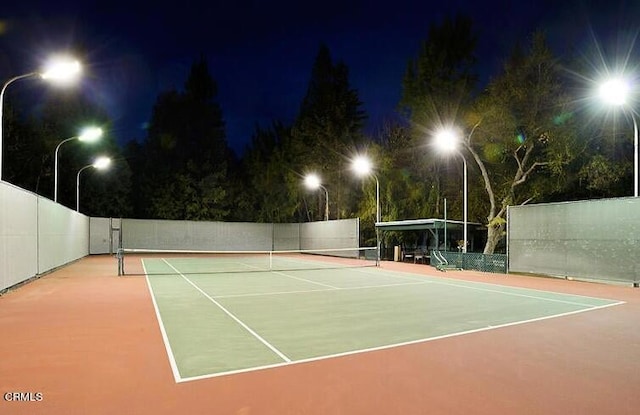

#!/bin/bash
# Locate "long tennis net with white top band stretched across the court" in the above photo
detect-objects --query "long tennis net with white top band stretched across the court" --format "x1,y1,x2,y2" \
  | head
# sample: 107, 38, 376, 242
117, 247, 378, 275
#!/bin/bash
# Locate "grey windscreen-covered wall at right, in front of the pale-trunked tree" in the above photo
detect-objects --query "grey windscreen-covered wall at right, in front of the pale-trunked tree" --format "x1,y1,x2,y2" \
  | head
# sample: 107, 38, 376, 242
507, 198, 640, 284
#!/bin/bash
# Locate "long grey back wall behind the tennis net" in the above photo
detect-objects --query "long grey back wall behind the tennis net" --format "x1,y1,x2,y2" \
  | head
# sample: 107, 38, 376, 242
119, 218, 359, 252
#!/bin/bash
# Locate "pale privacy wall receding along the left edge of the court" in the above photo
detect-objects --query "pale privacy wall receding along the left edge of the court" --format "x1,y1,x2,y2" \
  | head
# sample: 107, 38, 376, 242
0, 182, 89, 291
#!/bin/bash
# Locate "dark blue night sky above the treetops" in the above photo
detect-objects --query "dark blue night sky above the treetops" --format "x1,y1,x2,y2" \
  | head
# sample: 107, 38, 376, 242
0, 0, 640, 151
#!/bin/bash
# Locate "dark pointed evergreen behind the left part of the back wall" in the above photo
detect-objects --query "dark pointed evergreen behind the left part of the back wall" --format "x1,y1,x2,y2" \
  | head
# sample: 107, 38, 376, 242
130, 58, 235, 220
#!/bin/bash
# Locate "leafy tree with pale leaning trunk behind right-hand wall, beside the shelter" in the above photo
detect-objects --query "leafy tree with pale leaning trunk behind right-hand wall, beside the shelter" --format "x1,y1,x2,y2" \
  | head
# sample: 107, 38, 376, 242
464, 32, 576, 254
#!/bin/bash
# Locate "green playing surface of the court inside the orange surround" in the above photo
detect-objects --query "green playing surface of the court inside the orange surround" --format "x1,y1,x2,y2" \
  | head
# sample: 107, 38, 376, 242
143, 258, 620, 382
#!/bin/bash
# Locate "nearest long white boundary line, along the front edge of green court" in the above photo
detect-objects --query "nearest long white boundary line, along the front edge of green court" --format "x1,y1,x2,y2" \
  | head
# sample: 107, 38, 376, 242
177, 301, 624, 383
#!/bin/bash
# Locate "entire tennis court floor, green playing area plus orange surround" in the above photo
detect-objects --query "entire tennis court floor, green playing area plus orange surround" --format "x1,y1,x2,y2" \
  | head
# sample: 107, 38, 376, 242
0, 254, 640, 415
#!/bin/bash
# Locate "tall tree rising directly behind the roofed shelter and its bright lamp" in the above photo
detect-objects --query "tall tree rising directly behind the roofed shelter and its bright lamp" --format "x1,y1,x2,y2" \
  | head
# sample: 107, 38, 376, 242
396, 15, 478, 234
